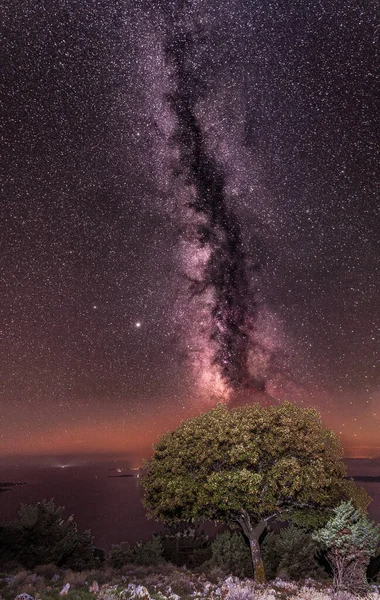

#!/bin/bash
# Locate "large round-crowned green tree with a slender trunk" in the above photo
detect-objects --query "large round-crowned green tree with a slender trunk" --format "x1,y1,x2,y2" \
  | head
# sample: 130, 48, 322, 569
142, 402, 370, 582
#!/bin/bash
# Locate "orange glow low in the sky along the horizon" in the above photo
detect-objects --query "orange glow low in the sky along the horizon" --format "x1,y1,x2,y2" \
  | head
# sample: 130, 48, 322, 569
0, 401, 380, 458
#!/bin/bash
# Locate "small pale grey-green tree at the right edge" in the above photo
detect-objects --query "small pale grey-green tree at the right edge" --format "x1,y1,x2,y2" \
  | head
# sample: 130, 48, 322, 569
312, 502, 380, 593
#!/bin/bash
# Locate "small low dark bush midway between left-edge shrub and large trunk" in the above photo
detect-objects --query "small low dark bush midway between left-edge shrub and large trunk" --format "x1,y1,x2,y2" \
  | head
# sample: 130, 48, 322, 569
107, 536, 164, 569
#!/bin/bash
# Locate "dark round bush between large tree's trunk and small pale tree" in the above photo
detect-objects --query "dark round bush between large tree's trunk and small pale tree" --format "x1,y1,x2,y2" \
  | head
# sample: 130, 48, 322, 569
262, 525, 323, 581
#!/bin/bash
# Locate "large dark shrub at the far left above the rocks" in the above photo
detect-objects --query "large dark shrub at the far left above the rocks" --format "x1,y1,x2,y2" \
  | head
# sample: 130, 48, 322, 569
1, 500, 96, 570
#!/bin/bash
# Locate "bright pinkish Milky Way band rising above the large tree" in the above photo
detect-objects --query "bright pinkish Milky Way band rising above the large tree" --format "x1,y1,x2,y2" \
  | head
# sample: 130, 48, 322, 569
144, 2, 292, 402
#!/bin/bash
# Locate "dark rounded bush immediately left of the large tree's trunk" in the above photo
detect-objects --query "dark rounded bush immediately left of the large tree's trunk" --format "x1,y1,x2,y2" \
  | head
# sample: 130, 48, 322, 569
207, 531, 253, 577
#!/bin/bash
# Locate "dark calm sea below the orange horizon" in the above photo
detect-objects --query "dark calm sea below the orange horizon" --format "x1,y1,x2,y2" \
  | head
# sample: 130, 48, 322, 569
0, 459, 380, 550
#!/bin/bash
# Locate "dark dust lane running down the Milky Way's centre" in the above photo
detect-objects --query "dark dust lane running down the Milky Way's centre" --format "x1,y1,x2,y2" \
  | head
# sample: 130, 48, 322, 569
165, 18, 265, 398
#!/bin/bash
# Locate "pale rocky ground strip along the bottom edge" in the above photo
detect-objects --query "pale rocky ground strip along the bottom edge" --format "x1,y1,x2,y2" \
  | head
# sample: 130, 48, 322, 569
0, 564, 380, 600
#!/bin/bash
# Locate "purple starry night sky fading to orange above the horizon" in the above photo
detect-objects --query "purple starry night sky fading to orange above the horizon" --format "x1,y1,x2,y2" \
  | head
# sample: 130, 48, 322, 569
0, 0, 380, 456
